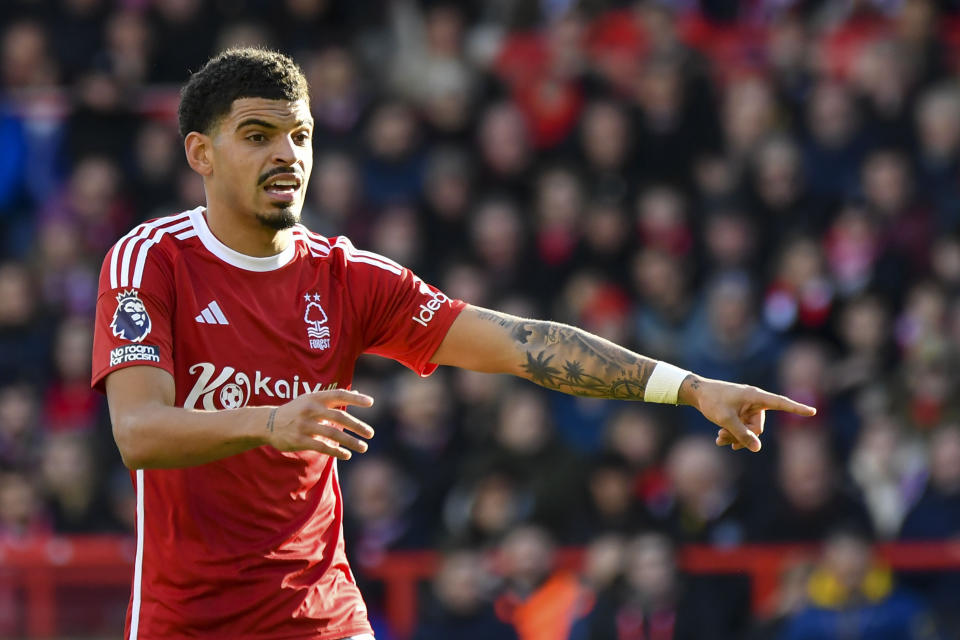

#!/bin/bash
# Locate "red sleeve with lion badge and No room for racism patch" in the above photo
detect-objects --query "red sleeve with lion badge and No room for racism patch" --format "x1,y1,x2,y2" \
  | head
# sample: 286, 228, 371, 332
91, 238, 174, 392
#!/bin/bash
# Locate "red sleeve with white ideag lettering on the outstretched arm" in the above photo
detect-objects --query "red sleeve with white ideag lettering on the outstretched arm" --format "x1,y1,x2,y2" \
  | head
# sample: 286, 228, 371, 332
338, 241, 466, 376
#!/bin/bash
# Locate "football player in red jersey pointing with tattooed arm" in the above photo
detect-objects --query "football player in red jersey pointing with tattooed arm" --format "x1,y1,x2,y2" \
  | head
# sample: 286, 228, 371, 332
93, 49, 814, 640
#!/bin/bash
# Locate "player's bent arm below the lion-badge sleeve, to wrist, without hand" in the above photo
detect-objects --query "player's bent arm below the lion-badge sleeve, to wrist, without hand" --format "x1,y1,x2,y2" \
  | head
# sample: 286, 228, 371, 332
106, 366, 271, 469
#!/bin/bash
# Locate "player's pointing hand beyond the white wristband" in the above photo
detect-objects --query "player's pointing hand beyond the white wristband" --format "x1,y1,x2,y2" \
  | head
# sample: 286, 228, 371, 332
678, 375, 817, 452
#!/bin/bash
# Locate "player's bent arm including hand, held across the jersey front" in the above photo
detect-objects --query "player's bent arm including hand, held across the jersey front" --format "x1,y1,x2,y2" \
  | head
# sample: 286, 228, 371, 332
106, 366, 373, 469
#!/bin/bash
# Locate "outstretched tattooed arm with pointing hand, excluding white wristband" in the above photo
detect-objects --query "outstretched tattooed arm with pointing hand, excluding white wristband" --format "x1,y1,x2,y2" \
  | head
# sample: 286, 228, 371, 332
431, 306, 816, 451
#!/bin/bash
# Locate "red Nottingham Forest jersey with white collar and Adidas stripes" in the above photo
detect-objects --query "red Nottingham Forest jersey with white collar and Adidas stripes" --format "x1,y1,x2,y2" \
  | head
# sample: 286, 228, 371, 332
93, 208, 464, 640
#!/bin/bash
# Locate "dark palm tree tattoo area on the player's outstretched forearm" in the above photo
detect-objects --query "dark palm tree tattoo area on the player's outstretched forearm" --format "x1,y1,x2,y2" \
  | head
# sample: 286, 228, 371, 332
480, 311, 657, 400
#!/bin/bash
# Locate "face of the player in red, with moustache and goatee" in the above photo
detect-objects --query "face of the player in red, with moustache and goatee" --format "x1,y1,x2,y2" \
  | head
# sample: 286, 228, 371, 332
208, 98, 313, 230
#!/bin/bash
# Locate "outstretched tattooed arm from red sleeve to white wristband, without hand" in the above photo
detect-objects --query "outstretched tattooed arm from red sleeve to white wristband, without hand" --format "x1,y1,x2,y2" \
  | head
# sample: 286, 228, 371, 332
431, 306, 668, 400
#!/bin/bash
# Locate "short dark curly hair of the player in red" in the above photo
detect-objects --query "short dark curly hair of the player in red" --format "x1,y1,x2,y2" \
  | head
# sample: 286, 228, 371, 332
178, 47, 310, 136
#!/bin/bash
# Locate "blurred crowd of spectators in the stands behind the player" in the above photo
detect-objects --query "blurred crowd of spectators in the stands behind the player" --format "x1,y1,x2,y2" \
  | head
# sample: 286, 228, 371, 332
0, 0, 960, 640
